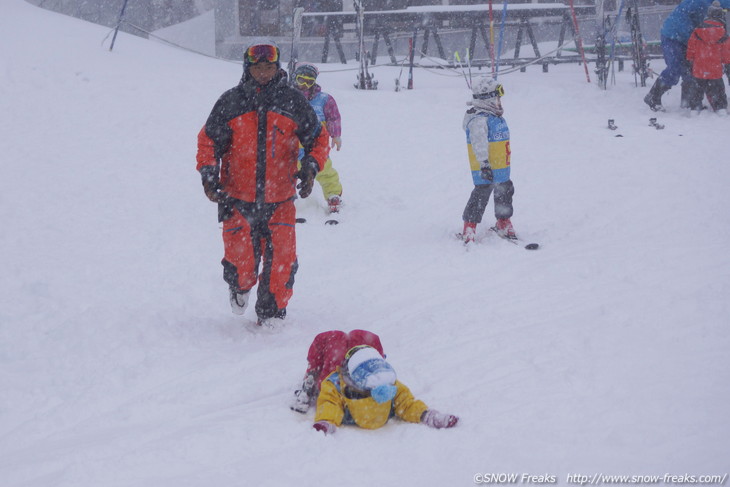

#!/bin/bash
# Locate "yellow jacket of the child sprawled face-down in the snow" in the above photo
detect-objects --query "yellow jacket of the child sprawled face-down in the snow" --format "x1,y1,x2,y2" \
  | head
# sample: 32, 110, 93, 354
314, 372, 428, 429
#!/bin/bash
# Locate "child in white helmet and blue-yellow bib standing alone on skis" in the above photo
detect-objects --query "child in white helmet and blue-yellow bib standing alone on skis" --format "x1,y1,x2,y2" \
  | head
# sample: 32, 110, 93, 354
461, 78, 517, 243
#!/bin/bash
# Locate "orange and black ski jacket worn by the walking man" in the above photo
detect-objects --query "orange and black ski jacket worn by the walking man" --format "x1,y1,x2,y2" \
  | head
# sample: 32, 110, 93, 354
197, 72, 329, 203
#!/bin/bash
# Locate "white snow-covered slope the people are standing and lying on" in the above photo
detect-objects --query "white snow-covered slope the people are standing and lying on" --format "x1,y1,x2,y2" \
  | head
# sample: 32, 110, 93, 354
0, 0, 730, 487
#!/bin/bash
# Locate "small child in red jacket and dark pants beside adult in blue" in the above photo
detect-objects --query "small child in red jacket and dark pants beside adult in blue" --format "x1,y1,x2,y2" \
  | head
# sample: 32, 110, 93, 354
687, 1, 730, 115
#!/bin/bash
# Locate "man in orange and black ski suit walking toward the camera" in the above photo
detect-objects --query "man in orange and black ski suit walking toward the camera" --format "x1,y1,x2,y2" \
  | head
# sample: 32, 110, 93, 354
197, 42, 329, 326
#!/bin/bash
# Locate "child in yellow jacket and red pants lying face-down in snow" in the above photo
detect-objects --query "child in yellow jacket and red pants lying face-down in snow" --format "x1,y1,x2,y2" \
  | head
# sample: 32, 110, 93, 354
291, 330, 459, 435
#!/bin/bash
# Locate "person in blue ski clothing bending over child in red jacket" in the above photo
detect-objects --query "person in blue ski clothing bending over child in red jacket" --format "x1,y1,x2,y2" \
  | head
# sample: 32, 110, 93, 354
644, 0, 730, 112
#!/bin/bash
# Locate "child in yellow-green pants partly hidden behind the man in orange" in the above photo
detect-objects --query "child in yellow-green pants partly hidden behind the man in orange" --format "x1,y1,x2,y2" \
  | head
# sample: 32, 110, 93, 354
292, 63, 342, 213
